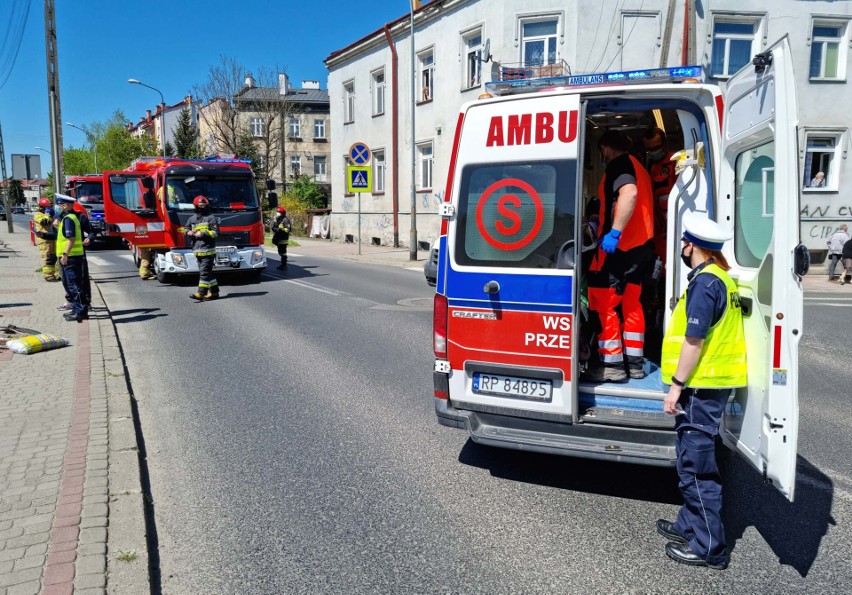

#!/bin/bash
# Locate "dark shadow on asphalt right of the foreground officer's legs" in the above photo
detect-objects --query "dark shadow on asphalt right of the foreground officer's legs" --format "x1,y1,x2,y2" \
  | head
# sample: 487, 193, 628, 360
722, 456, 837, 577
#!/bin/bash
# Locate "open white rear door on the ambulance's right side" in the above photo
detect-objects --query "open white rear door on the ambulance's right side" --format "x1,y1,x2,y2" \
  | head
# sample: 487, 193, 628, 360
720, 38, 808, 501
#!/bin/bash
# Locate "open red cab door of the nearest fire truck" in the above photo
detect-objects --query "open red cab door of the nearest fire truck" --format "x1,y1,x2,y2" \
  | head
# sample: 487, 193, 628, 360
104, 171, 167, 248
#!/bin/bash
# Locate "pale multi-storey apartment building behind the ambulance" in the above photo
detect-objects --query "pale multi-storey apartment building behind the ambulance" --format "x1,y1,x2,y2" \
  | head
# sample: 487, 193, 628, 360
325, 0, 852, 261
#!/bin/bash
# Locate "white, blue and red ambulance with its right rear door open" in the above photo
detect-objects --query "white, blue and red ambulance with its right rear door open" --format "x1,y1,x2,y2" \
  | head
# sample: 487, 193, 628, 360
433, 38, 810, 500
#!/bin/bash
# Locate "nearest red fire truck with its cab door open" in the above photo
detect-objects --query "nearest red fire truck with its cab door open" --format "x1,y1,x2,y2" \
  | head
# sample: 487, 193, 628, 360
103, 157, 277, 283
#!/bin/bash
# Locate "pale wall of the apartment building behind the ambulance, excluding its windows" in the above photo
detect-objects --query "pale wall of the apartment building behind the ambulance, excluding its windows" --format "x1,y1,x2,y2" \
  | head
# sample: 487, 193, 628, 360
326, 0, 852, 260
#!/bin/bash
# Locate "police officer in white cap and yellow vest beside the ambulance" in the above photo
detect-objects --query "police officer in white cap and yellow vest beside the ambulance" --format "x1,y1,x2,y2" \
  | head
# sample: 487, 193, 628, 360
657, 214, 747, 570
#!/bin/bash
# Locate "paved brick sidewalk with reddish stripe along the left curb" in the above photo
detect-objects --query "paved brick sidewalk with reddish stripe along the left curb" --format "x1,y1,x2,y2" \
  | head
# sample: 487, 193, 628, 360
0, 222, 150, 595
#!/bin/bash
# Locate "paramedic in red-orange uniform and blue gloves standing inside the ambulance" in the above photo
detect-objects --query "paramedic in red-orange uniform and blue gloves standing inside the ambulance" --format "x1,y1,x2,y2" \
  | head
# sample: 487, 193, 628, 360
583, 130, 654, 382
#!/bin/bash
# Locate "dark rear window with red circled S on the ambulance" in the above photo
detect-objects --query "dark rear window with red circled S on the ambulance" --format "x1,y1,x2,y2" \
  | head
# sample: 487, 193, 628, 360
454, 160, 577, 269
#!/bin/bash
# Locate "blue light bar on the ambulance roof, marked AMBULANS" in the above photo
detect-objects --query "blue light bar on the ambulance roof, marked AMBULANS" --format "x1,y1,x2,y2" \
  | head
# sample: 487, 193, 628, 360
485, 66, 704, 96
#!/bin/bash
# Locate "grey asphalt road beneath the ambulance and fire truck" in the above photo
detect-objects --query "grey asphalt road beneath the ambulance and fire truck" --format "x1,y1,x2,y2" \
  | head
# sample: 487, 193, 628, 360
75, 241, 852, 593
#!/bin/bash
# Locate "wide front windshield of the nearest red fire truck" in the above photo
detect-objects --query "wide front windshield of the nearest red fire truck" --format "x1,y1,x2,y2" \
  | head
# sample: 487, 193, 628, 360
166, 176, 258, 212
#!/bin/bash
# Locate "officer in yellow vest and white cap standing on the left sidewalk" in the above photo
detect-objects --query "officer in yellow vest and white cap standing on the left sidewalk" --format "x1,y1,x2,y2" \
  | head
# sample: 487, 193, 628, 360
56, 194, 89, 322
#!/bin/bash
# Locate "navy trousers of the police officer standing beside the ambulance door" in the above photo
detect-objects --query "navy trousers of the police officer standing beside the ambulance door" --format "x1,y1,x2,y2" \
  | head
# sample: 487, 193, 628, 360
674, 388, 731, 564
